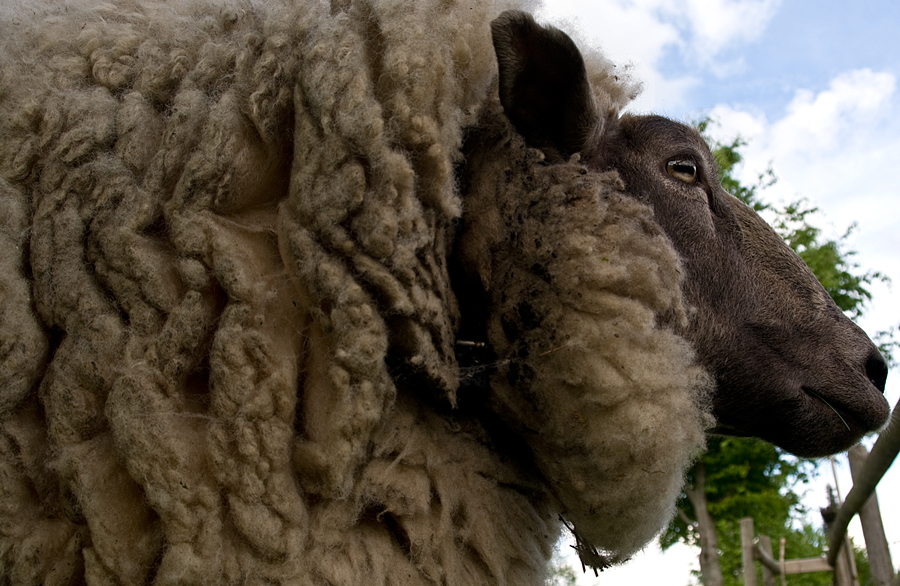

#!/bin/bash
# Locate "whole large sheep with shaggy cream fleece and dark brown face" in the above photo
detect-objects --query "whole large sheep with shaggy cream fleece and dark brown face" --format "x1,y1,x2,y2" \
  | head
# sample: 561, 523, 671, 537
0, 0, 887, 586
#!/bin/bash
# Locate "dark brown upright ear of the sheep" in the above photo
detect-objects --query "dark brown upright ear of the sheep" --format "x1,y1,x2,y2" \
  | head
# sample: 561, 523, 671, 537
491, 10, 600, 157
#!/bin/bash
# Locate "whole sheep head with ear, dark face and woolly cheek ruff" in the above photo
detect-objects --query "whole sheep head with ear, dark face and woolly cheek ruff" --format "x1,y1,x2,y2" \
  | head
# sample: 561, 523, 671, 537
455, 6, 888, 565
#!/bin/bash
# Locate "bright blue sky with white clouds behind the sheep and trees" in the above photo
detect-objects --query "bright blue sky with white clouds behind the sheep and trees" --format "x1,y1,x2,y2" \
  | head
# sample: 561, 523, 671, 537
537, 0, 900, 586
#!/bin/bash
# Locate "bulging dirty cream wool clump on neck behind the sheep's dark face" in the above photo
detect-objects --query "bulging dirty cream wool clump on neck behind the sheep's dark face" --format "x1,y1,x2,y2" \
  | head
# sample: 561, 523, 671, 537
460, 101, 713, 566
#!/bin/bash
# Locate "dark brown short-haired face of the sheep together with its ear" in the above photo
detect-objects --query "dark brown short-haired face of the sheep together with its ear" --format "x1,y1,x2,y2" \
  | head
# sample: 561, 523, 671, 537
492, 12, 889, 456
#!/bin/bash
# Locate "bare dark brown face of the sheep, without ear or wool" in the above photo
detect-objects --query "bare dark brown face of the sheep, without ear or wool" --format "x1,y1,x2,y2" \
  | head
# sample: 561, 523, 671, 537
591, 116, 889, 456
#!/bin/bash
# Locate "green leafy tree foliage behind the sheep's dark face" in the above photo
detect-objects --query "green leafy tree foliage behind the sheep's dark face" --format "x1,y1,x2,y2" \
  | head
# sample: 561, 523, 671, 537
660, 120, 898, 586
